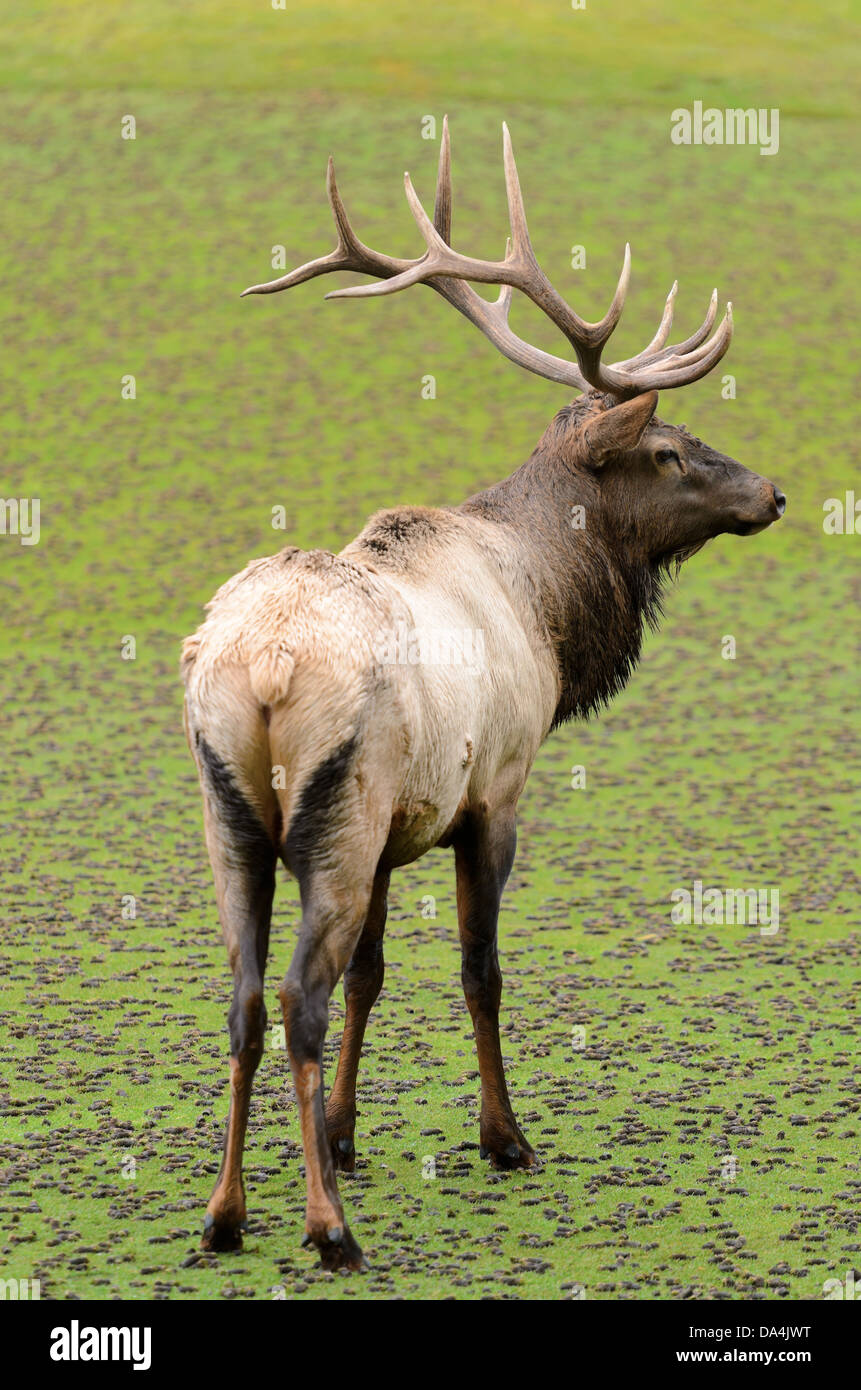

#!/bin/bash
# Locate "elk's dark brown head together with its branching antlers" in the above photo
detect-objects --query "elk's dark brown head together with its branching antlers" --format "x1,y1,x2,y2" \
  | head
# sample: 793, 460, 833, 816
243, 118, 786, 563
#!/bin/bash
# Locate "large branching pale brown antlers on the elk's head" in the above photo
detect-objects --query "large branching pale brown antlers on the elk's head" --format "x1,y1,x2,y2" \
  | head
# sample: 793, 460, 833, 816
242, 117, 733, 399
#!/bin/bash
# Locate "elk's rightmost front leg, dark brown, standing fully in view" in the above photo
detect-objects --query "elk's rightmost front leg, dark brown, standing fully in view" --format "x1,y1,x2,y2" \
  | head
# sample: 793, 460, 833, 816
453, 806, 538, 1168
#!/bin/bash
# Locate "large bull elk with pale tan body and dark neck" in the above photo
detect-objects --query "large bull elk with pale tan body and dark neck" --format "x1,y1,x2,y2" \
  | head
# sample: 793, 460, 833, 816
182, 122, 786, 1269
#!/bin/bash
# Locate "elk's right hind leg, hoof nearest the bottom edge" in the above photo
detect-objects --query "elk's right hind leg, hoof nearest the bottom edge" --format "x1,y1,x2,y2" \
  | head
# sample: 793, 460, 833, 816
278, 870, 373, 1269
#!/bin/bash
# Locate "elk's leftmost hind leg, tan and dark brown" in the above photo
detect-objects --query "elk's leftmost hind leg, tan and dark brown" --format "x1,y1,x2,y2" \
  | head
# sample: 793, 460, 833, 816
194, 755, 275, 1250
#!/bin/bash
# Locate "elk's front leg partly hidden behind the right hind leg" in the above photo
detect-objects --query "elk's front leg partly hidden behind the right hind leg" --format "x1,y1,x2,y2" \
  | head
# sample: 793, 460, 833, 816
325, 872, 389, 1173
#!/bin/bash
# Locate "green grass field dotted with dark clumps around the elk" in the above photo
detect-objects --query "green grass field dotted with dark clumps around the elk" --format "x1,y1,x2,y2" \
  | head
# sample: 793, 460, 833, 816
0, 0, 861, 1300
